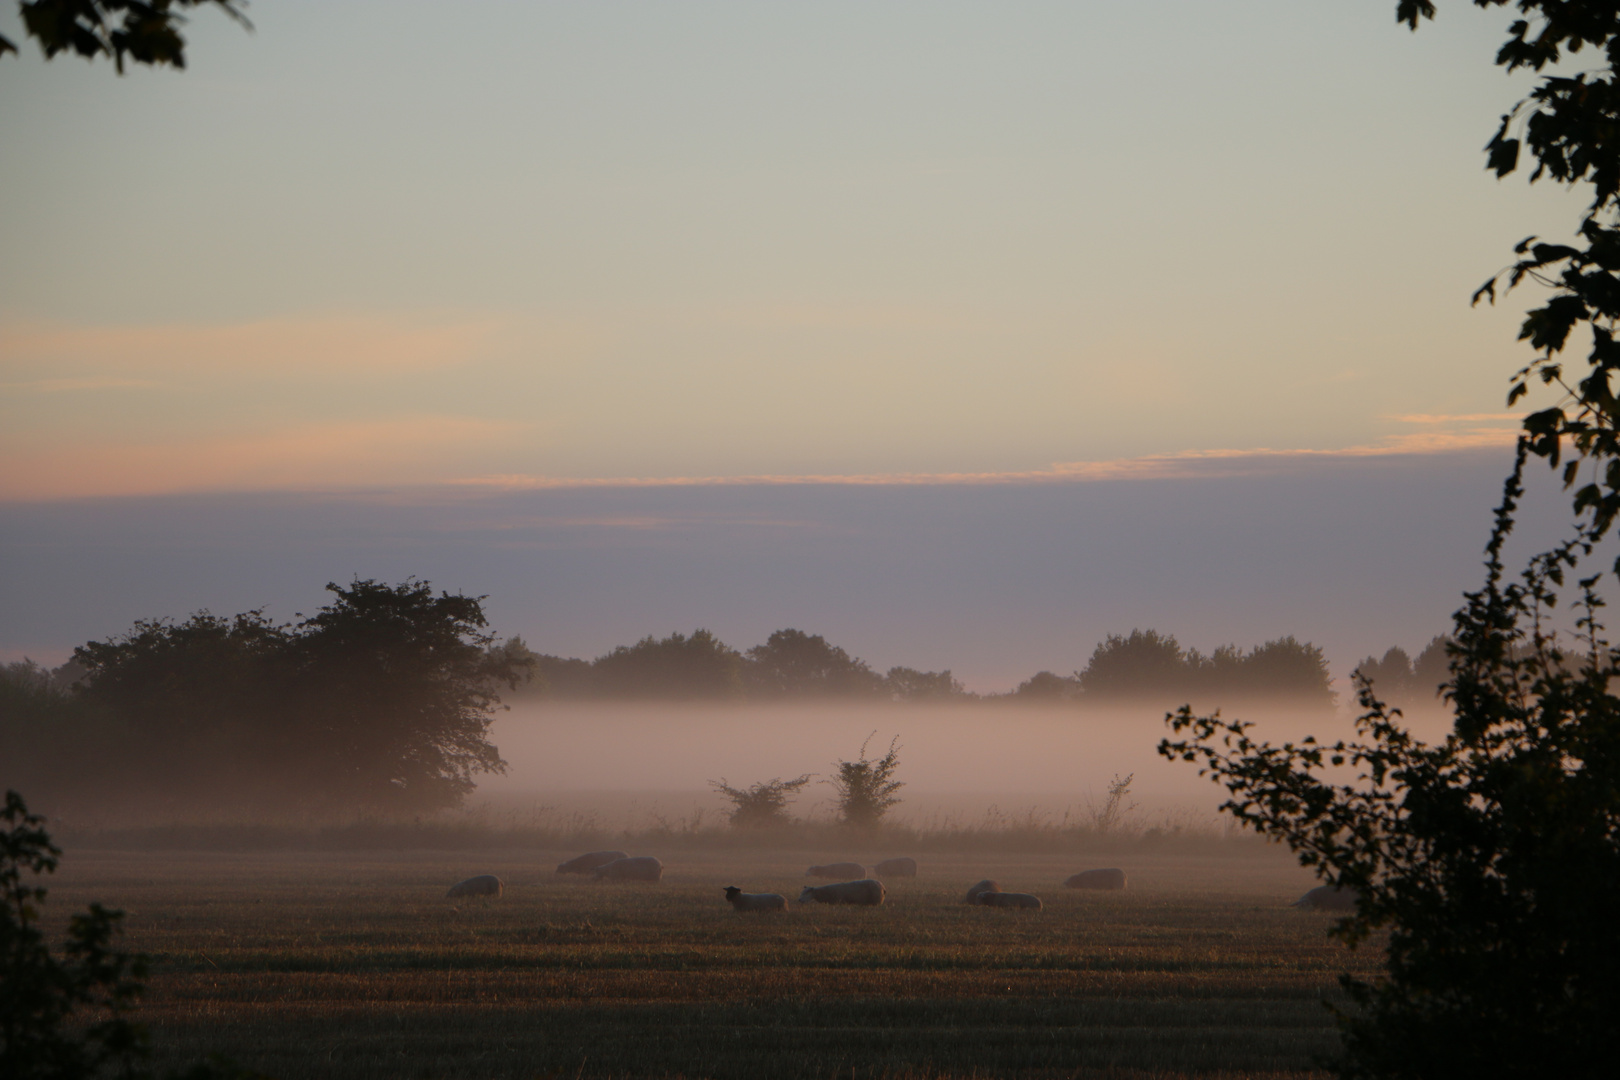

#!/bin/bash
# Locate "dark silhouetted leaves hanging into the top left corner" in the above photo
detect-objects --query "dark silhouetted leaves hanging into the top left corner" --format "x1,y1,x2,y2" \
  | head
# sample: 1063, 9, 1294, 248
0, 0, 251, 74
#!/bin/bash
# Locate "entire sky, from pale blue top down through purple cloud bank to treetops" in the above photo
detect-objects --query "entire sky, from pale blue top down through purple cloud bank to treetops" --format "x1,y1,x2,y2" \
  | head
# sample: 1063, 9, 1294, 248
0, 0, 1580, 690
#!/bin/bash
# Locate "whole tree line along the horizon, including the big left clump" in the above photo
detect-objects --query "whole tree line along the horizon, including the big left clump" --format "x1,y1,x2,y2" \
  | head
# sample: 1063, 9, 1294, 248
0, 580, 1445, 814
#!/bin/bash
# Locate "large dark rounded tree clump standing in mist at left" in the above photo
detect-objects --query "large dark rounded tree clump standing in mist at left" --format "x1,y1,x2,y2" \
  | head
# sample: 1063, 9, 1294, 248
55, 580, 528, 808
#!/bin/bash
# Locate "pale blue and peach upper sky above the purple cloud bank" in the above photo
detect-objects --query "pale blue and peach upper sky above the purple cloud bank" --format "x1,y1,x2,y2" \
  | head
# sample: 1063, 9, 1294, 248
0, 0, 1573, 497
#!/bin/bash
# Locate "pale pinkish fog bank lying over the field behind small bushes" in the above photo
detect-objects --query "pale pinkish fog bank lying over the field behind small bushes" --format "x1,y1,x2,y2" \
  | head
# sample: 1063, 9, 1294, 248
475, 703, 1447, 827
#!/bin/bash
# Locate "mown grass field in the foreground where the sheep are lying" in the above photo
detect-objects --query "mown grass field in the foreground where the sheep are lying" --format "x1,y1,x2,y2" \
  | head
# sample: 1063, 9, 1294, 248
47, 840, 1377, 1080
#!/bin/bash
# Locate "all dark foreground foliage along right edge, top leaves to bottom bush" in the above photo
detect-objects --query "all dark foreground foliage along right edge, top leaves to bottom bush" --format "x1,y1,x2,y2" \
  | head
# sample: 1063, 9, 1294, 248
1160, 0, 1620, 1077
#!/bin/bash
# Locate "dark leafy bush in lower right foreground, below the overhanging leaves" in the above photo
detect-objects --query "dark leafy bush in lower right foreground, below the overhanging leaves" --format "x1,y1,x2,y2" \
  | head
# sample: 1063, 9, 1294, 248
1158, 440, 1620, 1077
